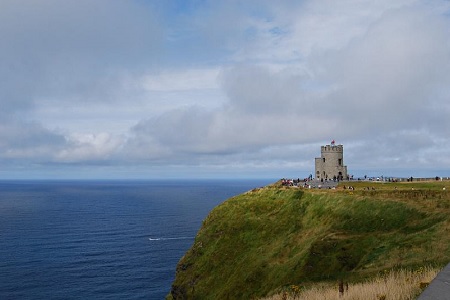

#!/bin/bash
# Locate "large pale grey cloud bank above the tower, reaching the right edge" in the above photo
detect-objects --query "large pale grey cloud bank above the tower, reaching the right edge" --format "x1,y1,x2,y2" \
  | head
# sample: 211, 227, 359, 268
115, 3, 450, 176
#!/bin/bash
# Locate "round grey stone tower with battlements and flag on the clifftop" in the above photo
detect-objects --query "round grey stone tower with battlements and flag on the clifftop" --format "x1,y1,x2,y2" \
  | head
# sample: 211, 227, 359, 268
315, 141, 347, 180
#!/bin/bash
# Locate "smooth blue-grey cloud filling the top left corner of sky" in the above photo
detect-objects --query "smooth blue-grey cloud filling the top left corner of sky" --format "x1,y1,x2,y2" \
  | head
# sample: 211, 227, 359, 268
0, 0, 163, 117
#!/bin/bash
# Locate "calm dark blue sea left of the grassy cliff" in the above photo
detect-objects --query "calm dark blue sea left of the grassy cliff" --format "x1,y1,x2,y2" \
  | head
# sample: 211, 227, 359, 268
0, 180, 268, 299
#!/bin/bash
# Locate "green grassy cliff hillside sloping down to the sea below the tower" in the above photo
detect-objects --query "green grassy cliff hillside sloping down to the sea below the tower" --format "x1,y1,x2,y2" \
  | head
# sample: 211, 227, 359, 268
169, 182, 450, 299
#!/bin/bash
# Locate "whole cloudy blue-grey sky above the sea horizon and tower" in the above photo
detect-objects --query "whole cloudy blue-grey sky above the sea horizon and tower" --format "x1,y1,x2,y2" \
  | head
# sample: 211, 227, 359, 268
0, 0, 450, 179
